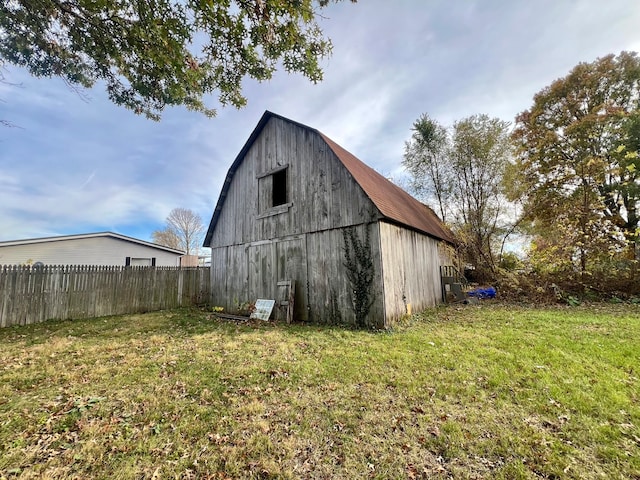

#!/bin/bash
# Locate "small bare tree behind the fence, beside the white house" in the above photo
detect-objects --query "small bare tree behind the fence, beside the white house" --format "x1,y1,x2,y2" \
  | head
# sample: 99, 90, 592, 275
151, 208, 204, 255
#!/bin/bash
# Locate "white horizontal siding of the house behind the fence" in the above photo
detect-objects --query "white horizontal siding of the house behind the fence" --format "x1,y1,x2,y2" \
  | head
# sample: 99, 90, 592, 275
0, 237, 180, 267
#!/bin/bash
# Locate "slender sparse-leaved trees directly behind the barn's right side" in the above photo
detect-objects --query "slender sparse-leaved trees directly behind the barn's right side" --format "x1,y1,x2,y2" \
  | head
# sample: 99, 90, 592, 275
403, 115, 513, 279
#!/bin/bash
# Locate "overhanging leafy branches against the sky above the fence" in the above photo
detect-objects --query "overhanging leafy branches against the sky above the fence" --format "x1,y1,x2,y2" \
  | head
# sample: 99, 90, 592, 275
0, 0, 355, 119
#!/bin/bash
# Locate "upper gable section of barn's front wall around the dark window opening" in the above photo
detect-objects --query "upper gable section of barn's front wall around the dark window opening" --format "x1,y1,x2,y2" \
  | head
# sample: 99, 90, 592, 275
211, 118, 377, 248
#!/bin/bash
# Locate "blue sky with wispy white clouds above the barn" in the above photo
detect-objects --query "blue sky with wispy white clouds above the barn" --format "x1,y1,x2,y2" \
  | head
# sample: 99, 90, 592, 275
0, 0, 640, 246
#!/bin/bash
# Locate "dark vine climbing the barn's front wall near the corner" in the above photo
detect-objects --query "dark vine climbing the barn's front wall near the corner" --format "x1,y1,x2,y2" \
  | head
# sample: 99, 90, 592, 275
342, 227, 374, 327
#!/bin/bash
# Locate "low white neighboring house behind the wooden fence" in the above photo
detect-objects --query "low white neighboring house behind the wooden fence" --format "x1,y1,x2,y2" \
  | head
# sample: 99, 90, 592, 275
0, 232, 184, 267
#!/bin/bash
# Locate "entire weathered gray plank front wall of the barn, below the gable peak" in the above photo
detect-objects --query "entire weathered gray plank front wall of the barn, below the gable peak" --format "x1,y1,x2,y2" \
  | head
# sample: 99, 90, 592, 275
211, 118, 384, 326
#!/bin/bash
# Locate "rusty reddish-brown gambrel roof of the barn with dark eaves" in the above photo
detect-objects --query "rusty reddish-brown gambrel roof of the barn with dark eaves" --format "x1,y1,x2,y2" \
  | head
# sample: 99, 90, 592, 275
204, 111, 454, 246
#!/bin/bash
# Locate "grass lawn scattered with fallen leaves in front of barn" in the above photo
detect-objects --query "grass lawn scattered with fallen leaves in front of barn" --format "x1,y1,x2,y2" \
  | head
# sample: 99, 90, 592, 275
0, 302, 640, 480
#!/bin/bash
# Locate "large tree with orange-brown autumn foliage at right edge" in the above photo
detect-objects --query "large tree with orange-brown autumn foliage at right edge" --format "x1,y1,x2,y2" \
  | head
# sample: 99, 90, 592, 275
510, 52, 640, 274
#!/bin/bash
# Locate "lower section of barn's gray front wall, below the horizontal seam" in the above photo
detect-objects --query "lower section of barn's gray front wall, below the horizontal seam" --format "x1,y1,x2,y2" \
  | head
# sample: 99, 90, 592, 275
211, 223, 386, 328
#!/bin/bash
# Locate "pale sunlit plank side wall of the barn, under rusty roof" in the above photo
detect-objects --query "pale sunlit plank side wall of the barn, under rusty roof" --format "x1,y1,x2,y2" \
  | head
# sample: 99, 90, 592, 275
379, 222, 442, 322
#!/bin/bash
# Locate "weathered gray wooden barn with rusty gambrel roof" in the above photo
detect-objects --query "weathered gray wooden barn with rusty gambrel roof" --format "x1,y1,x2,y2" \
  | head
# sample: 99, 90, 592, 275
204, 112, 453, 328
